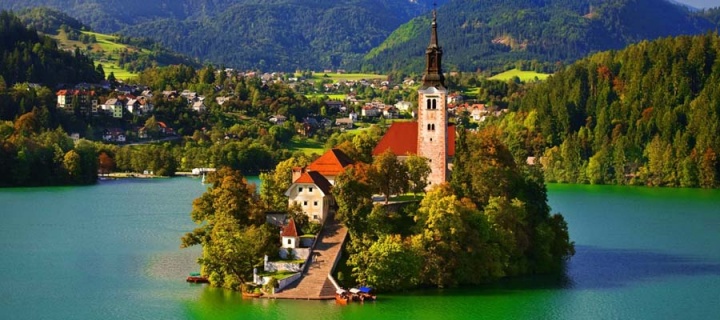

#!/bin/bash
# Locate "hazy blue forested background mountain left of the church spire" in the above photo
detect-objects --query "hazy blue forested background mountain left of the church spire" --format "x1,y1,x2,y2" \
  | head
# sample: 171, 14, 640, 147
0, 0, 446, 71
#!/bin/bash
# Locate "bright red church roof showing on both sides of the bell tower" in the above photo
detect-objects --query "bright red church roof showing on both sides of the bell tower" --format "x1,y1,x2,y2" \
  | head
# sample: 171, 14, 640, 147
373, 121, 455, 157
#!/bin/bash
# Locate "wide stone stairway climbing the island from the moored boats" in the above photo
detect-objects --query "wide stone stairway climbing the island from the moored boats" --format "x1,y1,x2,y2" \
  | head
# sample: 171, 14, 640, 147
264, 215, 347, 300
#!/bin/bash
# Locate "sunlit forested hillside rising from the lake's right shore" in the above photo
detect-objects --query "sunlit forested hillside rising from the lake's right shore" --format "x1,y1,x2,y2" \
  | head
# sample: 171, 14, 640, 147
492, 33, 720, 188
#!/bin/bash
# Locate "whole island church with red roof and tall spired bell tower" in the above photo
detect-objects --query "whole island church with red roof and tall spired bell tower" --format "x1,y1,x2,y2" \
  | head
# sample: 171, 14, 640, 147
373, 11, 455, 187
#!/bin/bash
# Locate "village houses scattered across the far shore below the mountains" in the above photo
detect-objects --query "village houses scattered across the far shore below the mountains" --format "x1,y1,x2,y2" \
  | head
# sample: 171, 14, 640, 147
56, 69, 503, 144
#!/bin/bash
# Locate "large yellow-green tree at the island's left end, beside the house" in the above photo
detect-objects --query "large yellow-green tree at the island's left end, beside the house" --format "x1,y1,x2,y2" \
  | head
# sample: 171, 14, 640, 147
182, 168, 279, 290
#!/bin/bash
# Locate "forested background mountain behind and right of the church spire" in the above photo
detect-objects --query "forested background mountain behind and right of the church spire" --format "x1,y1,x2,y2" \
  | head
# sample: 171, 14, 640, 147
362, 0, 715, 72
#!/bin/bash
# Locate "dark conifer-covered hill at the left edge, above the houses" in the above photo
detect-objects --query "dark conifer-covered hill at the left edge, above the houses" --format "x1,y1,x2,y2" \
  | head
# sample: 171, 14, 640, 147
0, 11, 102, 87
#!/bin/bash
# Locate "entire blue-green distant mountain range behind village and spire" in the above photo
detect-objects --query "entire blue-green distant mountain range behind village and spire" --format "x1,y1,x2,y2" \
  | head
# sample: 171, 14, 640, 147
0, 0, 717, 73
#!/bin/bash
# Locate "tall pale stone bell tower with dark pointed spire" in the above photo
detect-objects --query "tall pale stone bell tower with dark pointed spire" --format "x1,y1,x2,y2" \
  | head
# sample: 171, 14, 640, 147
417, 9, 449, 187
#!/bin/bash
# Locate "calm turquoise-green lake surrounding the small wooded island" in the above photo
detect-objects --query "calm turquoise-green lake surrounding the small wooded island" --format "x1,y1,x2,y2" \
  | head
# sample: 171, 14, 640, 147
0, 178, 720, 319
